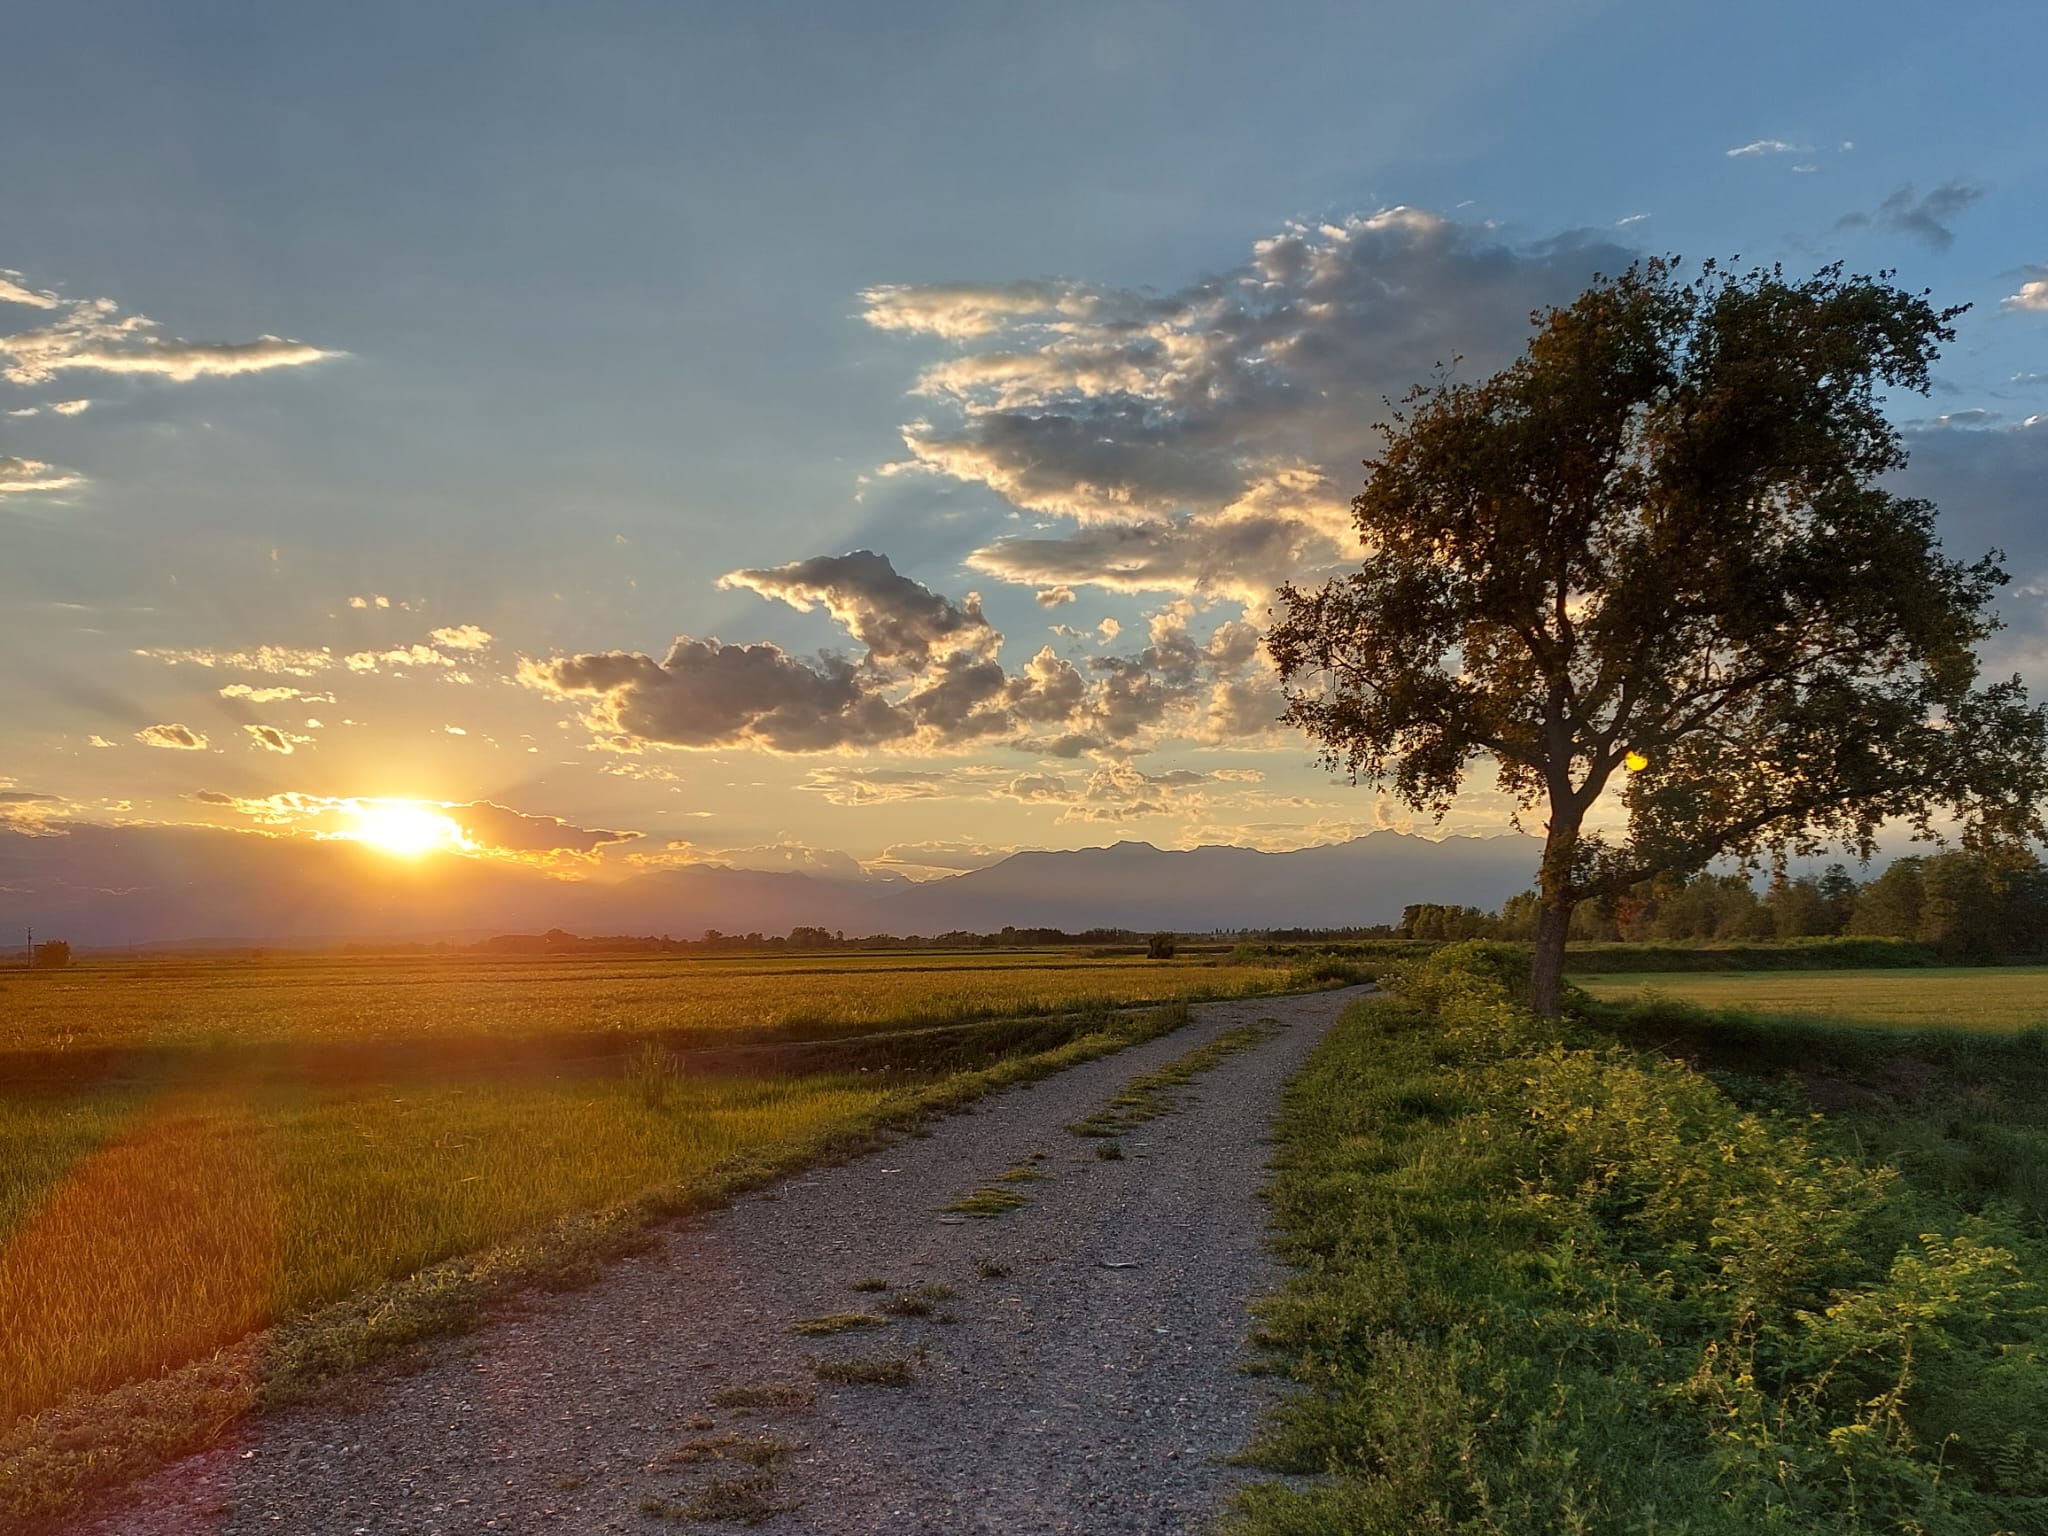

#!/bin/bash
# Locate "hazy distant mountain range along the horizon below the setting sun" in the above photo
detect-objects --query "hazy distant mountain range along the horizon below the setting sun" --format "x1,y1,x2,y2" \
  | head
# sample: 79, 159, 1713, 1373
0, 823, 1538, 948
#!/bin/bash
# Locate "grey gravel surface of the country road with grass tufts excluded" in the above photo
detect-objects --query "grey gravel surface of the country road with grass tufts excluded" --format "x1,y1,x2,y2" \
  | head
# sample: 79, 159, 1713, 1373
80, 989, 1356, 1536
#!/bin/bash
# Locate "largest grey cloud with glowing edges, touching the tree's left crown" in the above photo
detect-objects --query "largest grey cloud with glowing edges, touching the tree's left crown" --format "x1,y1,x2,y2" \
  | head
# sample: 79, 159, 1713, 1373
868, 209, 1632, 602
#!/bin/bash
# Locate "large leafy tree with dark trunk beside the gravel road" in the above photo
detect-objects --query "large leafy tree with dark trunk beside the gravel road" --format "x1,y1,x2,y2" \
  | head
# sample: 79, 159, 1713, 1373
1268, 260, 2048, 1018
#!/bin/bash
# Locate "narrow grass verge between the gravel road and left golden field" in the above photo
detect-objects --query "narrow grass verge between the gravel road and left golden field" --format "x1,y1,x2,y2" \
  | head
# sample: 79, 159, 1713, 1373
0, 1004, 1190, 1536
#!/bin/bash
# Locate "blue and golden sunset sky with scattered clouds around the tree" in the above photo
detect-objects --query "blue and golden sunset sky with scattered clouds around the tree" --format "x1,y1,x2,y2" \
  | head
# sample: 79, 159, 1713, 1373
0, 0, 2048, 897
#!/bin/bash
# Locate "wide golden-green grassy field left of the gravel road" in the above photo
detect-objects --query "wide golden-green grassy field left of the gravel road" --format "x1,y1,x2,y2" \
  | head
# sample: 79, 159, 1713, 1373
0, 952, 1290, 1474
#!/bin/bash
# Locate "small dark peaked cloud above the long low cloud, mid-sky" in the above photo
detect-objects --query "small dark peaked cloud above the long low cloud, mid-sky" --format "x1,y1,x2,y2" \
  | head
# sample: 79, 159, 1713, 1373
719, 549, 1001, 670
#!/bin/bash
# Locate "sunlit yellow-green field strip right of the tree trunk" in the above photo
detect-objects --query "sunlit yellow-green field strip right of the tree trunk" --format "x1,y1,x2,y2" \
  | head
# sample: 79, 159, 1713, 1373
1571, 965, 2048, 1034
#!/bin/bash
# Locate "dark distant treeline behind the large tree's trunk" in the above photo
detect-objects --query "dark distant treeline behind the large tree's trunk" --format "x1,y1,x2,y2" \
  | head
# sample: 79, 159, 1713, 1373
1401, 852, 2048, 961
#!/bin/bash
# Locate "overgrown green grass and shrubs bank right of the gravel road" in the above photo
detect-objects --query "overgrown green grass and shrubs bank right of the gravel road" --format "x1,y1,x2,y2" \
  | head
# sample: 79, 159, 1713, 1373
1229, 944, 2048, 1536
